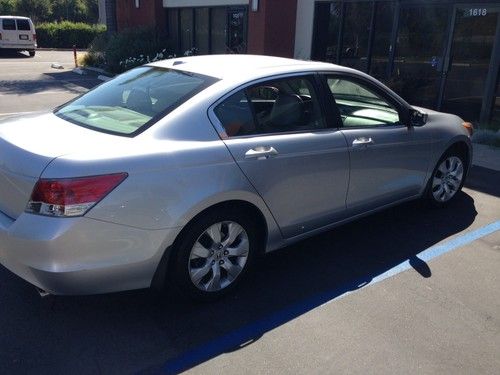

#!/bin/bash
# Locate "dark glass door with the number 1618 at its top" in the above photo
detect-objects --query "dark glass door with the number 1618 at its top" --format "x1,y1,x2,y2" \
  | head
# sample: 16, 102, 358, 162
440, 4, 500, 122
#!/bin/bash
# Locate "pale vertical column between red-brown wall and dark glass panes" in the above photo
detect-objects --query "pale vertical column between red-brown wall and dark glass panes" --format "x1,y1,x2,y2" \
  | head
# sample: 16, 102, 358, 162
293, 0, 315, 60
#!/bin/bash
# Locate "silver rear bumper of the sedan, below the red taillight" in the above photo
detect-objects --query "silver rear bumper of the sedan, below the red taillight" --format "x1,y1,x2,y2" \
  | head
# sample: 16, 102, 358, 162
0, 212, 180, 295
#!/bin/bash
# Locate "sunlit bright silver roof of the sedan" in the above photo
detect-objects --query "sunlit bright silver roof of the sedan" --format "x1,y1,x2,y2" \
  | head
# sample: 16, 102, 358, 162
148, 55, 352, 79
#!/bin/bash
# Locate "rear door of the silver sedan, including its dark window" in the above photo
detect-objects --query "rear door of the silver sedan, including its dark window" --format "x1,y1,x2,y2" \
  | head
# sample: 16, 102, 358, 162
209, 75, 349, 238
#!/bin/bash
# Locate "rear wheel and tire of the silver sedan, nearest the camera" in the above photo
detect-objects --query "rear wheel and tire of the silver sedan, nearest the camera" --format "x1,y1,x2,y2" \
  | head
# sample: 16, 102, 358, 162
170, 209, 259, 301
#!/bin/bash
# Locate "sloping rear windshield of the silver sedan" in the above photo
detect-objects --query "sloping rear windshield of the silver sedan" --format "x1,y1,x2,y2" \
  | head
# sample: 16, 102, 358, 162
54, 67, 216, 136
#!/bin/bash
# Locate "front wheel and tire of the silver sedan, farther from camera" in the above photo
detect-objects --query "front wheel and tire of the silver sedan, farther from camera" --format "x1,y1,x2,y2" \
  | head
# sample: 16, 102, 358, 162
424, 151, 467, 208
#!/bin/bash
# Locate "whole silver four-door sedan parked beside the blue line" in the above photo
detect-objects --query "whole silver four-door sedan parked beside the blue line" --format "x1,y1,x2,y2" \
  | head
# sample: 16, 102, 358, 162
0, 55, 472, 299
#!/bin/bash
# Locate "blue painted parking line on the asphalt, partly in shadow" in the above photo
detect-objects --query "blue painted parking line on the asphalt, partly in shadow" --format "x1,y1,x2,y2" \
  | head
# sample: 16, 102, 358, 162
162, 220, 500, 374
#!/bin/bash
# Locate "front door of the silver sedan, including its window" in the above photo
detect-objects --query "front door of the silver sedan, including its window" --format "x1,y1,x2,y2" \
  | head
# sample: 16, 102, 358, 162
324, 75, 432, 215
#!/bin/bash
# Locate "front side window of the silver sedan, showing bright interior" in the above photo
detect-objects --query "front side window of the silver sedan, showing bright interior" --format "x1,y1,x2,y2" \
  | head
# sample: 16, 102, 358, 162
327, 77, 399, 127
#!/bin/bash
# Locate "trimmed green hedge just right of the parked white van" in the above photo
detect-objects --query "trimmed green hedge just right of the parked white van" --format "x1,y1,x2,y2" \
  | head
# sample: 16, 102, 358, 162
36, 21, 106, 48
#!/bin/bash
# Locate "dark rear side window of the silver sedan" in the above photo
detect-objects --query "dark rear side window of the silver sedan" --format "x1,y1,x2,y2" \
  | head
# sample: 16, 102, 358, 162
215, 77, 325, 137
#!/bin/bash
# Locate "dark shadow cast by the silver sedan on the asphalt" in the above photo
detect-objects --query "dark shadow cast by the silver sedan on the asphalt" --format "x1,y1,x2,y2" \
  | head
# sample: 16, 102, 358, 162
0, 193, 477, 374
